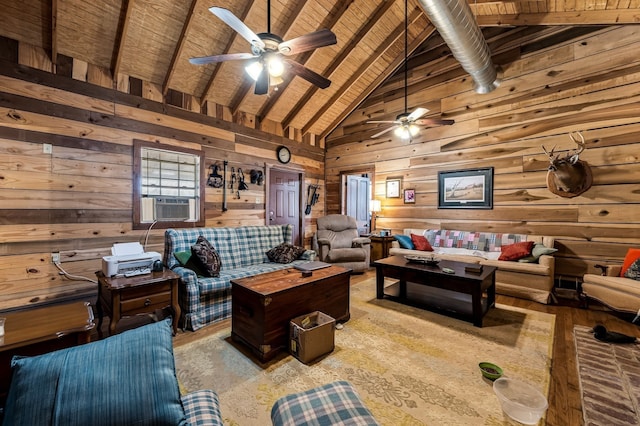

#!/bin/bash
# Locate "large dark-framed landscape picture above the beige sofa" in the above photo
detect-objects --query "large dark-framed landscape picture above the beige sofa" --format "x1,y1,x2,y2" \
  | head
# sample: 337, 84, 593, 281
438, 167, 493, 209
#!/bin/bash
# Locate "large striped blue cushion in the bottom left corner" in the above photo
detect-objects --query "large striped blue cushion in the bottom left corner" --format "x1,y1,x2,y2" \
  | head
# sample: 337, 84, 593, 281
4, 319, 186, 426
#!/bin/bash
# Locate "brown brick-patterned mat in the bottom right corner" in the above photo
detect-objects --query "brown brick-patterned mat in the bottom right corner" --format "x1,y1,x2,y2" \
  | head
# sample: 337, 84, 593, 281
573, 326, 640, 426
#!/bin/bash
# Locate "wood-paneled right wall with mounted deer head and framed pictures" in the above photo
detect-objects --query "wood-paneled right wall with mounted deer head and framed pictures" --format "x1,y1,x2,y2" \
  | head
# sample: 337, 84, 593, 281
326, 25, 640, 280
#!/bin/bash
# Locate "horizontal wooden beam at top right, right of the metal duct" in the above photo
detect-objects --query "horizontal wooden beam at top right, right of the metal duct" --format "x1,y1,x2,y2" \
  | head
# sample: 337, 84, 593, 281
476, 9, 640, 27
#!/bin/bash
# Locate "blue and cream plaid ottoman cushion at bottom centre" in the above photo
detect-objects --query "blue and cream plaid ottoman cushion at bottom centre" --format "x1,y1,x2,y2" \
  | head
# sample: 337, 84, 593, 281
271, 381, 379, 426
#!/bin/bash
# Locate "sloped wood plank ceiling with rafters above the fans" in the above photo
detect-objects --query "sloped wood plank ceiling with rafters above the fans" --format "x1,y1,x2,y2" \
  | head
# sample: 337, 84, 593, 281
0, 0, 640, 137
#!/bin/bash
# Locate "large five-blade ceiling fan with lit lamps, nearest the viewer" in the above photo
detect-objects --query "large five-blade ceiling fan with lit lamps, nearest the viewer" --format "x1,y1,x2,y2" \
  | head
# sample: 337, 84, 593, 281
189, 1, 337, 95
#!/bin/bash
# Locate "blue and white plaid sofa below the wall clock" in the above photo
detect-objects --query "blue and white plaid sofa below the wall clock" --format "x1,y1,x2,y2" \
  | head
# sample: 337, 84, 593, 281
164, 225, 315, 331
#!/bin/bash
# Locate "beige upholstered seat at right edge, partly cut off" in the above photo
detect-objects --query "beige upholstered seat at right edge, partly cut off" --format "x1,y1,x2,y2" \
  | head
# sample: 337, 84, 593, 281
581, 265, 640, 314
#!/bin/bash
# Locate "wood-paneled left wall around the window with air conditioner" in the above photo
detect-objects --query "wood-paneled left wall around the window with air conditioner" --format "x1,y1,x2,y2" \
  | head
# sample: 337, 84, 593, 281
0, 39, 324, 309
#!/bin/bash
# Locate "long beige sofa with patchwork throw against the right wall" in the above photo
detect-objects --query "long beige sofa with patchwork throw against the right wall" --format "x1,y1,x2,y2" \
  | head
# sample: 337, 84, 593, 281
389, 229, 555, 304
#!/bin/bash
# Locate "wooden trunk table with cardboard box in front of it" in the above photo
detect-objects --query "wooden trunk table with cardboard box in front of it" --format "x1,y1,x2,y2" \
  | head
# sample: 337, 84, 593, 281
231, 265, 351, 362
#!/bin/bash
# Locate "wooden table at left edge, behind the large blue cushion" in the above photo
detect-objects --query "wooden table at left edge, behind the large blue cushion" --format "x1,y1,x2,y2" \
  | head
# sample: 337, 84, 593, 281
0, 302, 95, 401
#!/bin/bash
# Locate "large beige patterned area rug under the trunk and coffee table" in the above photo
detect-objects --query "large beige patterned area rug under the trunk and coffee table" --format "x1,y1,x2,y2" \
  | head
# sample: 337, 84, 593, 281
175, 278, 555, 426
